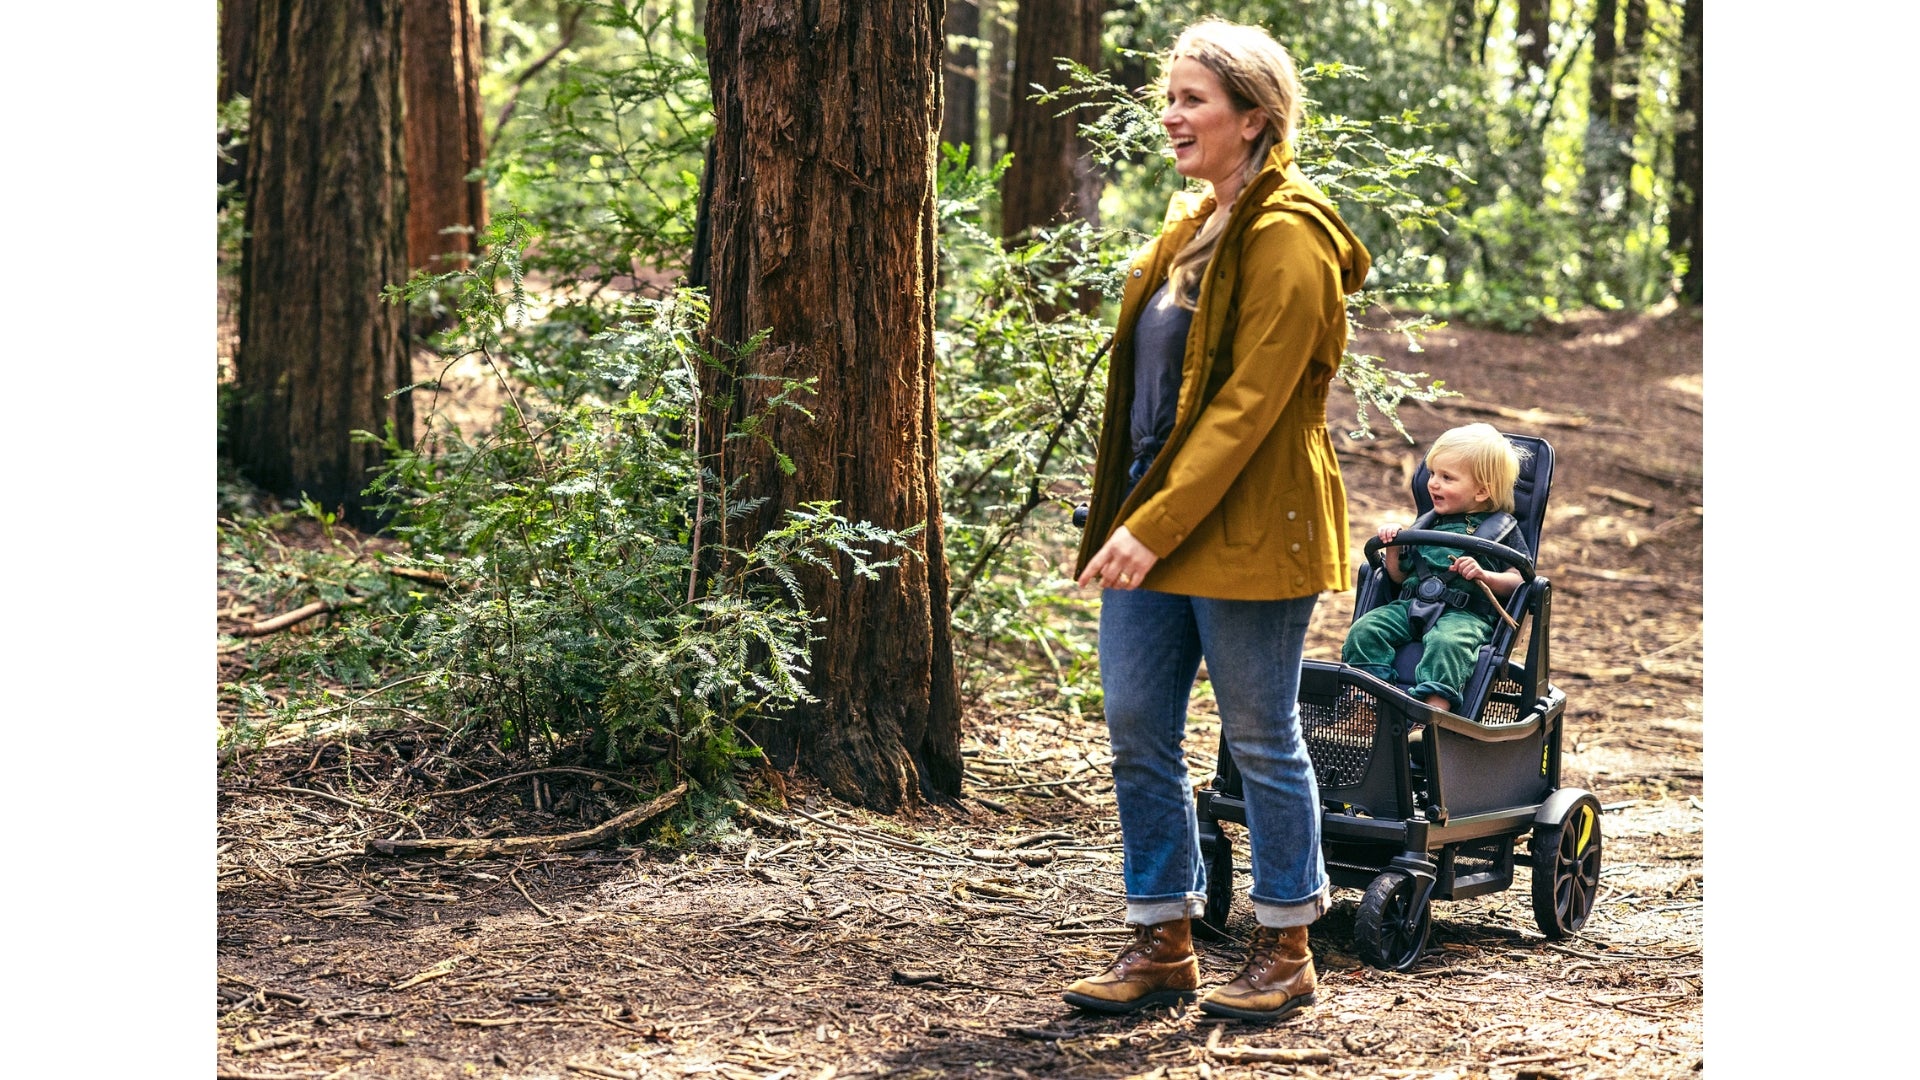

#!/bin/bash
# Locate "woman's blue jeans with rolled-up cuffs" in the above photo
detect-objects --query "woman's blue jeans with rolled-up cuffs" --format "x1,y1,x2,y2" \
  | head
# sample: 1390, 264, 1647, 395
1100, 588, 1329, 926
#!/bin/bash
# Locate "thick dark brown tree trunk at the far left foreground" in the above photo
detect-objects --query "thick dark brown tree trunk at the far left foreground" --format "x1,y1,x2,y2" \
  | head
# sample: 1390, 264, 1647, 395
228, 0, 413, 527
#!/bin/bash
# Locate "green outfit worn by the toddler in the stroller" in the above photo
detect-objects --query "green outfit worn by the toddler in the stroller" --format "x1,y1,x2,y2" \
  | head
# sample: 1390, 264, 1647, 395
1340, 513, 1530, 711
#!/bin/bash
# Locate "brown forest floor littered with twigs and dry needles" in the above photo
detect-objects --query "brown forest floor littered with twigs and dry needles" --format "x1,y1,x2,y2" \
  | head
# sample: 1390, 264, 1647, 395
215, 309, 1705, 1080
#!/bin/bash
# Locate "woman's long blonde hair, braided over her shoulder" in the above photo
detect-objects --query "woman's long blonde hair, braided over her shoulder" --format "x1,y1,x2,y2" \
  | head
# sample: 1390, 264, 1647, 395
1160, 15, 1306, 311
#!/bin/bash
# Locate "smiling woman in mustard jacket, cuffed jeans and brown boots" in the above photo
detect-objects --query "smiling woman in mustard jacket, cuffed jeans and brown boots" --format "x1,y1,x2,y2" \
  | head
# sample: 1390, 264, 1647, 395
1066, 19, 1371, 1019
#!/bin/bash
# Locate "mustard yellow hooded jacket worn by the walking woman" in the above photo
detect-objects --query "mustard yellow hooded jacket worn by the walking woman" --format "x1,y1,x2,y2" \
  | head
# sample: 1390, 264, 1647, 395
1073, 146, 1373, 600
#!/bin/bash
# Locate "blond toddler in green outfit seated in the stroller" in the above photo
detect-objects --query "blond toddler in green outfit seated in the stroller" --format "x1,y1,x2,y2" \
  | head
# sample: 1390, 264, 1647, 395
1340, 423, 1532, 711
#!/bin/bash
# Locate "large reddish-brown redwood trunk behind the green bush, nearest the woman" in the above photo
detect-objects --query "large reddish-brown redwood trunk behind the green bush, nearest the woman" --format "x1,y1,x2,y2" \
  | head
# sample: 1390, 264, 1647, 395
701, 0, 960, 809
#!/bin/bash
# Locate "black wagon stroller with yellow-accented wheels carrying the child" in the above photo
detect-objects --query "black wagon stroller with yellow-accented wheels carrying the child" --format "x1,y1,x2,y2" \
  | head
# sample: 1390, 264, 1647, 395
1196, 434, 1601, 970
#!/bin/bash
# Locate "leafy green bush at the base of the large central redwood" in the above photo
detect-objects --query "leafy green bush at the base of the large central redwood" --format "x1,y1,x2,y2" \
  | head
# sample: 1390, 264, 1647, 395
372, 226, 921, 784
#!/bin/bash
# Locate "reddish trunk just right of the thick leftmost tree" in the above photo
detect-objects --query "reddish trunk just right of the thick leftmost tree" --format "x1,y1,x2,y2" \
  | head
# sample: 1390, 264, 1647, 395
401, 0, 486, 273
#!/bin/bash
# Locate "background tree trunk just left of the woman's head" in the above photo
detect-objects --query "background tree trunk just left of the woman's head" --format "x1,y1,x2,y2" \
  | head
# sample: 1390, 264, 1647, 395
1000, 0, 1104, 238
